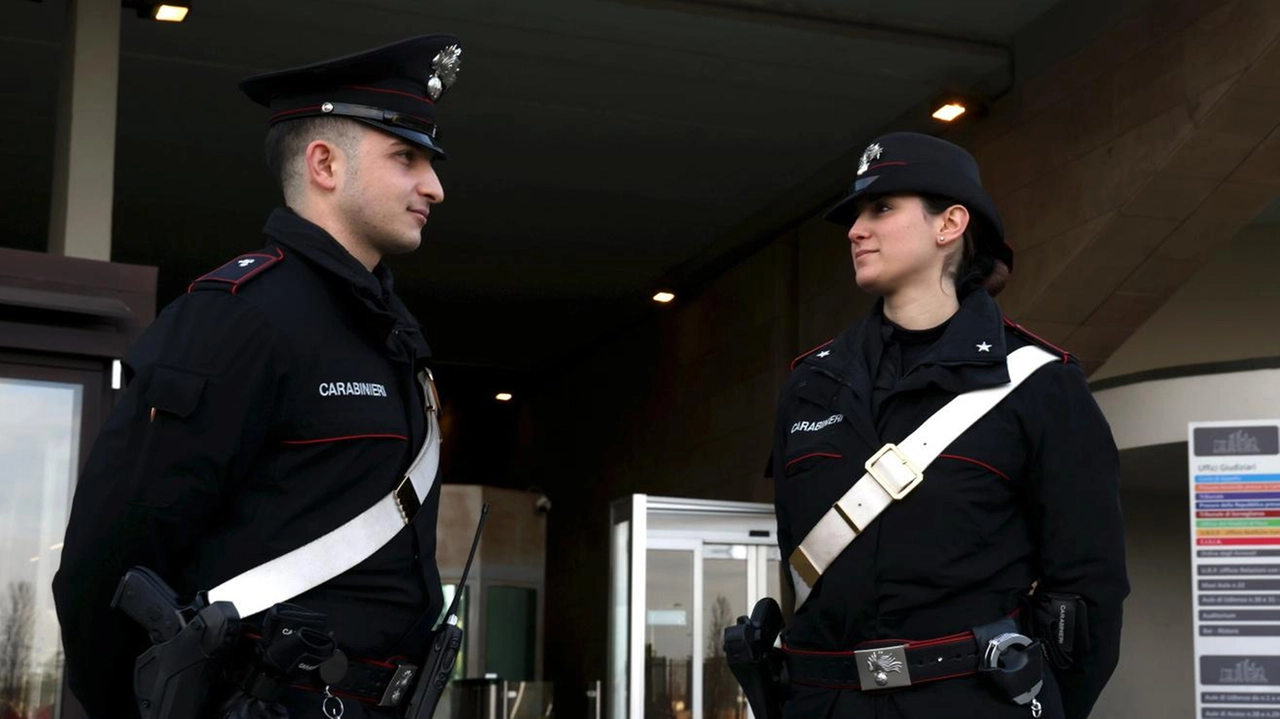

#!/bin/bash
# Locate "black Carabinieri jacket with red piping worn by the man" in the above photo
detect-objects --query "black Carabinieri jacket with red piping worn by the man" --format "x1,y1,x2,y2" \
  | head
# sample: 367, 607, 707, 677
54, 210, 442, 718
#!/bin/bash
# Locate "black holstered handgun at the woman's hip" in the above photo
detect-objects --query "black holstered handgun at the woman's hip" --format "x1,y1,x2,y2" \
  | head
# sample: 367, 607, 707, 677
724, 597, 786, 719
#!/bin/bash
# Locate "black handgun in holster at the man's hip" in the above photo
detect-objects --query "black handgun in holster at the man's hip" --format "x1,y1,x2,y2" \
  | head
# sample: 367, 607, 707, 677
111, 567, 239, 719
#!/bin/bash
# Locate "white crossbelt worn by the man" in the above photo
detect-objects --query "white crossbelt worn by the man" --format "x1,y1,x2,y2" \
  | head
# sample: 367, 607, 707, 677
209, 370, 440, 617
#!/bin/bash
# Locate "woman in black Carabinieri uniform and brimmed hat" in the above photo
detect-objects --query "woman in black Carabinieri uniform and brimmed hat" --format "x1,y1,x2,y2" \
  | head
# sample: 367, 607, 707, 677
772, 133, 1128, 719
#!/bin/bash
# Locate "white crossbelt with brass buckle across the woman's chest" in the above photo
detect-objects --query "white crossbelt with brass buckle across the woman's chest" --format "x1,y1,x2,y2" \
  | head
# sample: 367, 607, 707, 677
790, 345, 1061, 609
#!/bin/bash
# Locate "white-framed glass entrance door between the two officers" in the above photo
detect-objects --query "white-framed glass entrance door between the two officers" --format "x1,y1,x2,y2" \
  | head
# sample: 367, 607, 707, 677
607, 494, 780, 719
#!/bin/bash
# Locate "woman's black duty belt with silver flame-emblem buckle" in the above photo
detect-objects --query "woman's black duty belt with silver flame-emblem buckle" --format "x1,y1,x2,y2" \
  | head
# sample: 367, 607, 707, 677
782, 632, 983, 691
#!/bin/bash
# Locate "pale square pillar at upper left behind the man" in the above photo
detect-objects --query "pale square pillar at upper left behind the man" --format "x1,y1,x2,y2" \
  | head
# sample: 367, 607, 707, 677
49, 0, 120, 261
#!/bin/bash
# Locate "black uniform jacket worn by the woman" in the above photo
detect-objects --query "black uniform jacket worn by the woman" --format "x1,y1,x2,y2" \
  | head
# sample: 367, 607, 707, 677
772, 290, 1129, 719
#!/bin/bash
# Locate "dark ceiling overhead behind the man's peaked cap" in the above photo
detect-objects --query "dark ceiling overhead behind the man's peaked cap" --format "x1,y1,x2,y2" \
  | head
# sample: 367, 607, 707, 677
0, 0, 1056, 374
